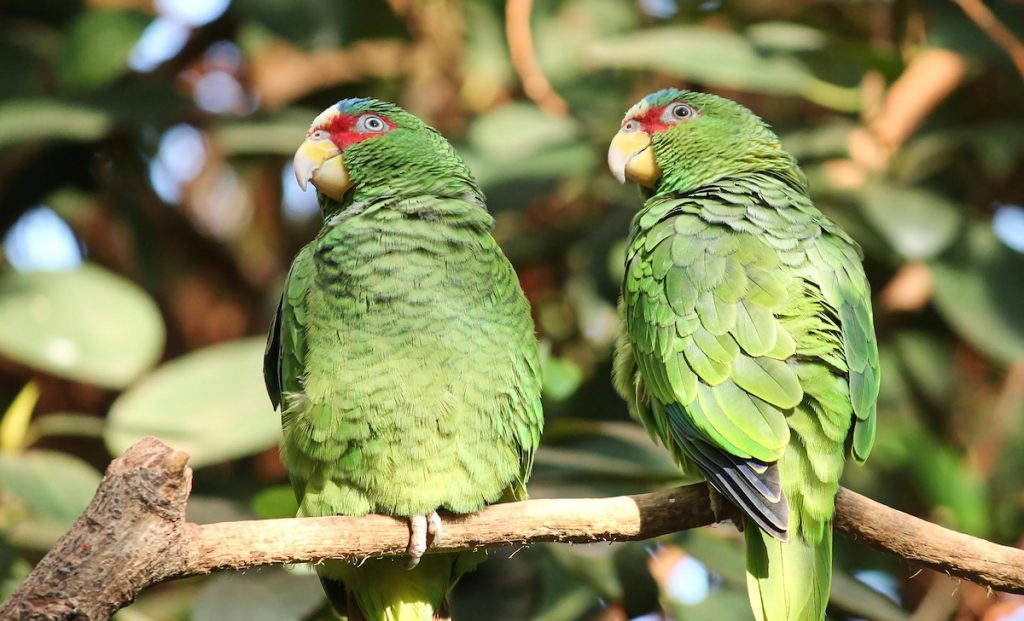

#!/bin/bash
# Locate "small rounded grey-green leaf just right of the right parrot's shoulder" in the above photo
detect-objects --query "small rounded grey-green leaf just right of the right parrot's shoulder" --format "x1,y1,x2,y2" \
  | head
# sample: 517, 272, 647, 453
862, 181, 961, 259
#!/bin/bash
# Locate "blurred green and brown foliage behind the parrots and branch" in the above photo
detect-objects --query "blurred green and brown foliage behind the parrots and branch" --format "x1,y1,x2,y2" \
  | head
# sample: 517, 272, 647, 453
0, 0, 1024, 621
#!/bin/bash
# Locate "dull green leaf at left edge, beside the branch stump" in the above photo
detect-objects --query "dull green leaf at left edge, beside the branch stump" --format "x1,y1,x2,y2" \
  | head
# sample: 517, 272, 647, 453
0, 450, 99, 549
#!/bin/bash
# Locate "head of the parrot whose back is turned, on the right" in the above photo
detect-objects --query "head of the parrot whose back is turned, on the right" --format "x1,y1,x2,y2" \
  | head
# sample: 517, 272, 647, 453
608, 88, 805, 194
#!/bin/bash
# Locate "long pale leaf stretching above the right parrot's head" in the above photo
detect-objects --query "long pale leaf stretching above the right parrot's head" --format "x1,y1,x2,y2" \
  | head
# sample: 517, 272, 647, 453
588, 26, 859, 110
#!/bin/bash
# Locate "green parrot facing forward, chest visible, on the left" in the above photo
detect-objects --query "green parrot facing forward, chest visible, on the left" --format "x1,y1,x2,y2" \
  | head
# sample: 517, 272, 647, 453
264, 98, 543, 621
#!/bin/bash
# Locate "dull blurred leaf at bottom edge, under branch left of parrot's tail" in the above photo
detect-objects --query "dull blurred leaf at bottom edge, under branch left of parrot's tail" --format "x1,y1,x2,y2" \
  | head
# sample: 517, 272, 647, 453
191, 567, 324, 621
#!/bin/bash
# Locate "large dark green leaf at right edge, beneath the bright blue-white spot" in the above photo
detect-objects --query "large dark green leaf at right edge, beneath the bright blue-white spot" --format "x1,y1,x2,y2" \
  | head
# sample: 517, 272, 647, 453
931, 222, 1024, 365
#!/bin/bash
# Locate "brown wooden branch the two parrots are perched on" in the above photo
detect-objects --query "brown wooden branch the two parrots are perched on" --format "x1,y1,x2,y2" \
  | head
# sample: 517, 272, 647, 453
6, 438, 1024, 620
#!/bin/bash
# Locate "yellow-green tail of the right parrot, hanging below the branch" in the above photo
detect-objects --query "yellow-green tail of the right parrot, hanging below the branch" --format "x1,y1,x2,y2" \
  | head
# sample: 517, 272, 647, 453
744, 528, 831, 621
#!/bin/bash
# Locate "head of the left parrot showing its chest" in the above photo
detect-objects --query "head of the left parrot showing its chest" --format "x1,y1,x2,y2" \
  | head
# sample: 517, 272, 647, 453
295, 98, 483, 215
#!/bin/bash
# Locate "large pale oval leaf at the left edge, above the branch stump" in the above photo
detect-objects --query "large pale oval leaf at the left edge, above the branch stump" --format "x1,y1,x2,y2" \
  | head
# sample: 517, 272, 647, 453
0, 264, 164, 388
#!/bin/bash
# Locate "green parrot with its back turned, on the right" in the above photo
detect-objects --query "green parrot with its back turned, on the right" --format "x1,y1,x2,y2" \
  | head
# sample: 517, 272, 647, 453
608, 89, 879, 621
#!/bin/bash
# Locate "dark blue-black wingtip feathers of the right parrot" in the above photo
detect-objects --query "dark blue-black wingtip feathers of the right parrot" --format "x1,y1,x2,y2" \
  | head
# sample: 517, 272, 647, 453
666, 404, 790, 541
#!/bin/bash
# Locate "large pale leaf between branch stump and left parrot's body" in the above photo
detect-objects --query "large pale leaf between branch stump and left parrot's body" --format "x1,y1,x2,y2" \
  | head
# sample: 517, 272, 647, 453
104, 337, 281, 466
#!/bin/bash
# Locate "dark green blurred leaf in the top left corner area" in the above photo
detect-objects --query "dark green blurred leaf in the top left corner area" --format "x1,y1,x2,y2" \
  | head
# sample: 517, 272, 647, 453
60, 9, 150, 89
